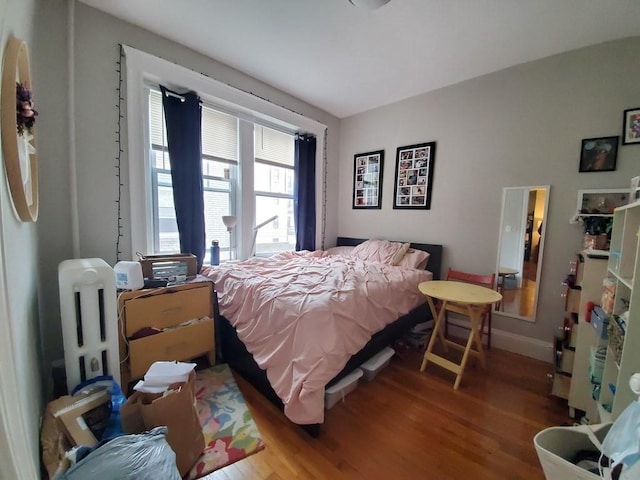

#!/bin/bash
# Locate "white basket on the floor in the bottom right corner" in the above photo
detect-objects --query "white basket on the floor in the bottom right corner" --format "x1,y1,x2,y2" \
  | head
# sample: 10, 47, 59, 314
533, 423, 612, 480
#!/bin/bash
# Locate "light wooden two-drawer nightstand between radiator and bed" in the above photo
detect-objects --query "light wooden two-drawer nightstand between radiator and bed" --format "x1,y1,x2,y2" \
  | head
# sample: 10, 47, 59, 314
118, 281, 215, 388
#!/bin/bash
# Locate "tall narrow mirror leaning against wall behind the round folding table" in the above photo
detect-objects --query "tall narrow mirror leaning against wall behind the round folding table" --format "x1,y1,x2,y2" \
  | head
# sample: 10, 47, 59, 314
494, 185, 550, 322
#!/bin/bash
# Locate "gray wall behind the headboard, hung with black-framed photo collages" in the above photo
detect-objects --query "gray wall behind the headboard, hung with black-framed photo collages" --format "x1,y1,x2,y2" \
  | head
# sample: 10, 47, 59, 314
338, 37, 640, 344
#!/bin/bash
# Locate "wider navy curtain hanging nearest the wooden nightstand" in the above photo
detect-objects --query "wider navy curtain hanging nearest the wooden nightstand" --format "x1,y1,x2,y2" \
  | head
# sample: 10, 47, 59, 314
160, 86, 206, 272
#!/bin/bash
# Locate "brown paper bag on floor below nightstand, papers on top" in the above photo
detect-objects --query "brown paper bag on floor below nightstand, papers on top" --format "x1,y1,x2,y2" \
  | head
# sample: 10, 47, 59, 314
120, 372, 205, 476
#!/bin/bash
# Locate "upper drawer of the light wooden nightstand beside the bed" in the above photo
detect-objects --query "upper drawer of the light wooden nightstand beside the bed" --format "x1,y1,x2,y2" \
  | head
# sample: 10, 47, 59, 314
124, 283, 213, 337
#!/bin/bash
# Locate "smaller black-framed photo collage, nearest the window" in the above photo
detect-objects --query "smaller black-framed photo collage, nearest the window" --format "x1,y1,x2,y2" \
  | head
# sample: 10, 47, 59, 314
353, 150, 384, 208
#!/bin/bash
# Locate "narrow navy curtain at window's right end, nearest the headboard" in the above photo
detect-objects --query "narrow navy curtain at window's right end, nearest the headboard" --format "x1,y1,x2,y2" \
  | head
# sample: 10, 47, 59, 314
293, 135, 316, 250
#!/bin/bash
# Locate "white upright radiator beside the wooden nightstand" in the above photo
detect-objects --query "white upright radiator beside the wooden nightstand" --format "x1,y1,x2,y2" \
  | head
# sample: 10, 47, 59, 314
58, 258, 120, 394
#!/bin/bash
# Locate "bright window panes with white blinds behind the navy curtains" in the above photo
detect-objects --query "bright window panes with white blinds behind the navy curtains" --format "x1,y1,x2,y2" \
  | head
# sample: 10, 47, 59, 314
147, 86, 295, 263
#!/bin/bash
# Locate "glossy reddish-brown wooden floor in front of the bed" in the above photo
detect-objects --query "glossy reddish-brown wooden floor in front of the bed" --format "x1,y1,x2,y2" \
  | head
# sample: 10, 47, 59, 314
206, 349, 571, 480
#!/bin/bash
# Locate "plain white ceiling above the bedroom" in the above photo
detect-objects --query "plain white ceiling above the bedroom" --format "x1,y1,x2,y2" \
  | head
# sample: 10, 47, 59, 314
80, 0, 640, 118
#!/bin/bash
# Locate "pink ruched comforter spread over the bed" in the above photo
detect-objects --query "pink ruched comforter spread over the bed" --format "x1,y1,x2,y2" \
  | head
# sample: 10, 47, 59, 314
203, 250, 431, 424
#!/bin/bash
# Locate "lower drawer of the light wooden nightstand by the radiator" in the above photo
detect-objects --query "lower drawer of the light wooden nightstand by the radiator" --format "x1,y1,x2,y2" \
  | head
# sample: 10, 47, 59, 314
129, 316, 215, 378
